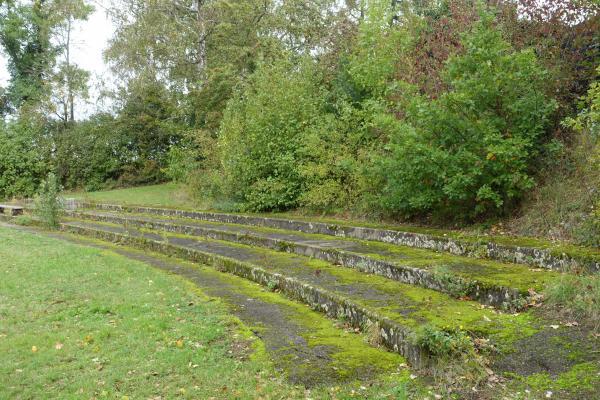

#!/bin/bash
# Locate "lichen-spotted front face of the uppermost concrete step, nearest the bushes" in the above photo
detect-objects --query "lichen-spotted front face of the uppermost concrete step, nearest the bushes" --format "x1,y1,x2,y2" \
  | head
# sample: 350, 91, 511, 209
77, 202, 600, 272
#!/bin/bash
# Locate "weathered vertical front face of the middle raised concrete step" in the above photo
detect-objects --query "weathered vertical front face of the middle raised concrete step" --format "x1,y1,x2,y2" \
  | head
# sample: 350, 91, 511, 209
69, 212, 528, 309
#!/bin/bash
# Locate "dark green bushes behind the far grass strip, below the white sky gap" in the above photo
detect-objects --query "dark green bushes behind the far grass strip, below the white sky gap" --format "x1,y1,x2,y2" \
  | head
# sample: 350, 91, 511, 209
49, 80, 189, 190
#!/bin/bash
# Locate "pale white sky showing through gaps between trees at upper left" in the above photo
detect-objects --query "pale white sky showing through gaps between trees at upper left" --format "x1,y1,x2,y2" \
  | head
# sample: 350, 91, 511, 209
0, 0, 114, 112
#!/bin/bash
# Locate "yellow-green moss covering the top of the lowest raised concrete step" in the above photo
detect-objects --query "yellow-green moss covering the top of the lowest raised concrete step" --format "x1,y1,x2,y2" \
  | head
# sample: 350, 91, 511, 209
123, 223, 537, 349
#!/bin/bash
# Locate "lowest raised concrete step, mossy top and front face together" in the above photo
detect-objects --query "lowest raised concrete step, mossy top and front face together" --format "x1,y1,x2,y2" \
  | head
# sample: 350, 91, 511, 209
62, 222, 536, 367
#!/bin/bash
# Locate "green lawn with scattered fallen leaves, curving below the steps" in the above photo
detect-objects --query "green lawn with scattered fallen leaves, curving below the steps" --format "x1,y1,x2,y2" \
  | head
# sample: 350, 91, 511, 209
0, 227, 410, 399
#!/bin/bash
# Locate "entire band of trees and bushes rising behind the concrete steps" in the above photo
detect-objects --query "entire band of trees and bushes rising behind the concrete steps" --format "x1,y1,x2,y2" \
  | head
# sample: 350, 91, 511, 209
0, 0, 600, 246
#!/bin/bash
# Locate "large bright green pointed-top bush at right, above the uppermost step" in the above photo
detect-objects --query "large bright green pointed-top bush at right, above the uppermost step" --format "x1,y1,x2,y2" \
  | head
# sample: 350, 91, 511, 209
373, 16, 556, 218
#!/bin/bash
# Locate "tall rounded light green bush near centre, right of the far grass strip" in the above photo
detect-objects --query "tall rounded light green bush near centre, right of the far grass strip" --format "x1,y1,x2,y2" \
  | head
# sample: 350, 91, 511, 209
219, 61, 330, 211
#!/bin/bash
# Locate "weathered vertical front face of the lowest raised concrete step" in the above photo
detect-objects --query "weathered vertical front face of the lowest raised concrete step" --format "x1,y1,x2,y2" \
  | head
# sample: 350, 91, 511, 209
60, 224, 431, 368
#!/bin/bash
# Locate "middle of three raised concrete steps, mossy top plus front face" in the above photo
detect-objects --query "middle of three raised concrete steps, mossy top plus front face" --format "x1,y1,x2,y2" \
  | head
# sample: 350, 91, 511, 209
70, 212, 558, 308
